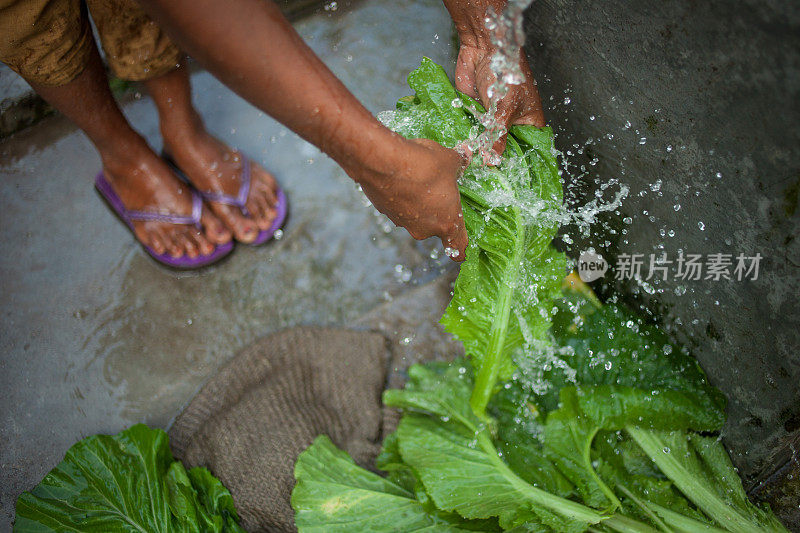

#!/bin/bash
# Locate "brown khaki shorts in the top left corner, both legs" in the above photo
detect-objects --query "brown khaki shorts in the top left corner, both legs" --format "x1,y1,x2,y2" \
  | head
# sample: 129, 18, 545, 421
0, 0, 181, 86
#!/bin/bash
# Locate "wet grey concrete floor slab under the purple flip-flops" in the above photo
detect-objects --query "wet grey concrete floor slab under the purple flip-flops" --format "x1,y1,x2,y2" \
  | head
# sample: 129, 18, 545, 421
0, 0, 454, 531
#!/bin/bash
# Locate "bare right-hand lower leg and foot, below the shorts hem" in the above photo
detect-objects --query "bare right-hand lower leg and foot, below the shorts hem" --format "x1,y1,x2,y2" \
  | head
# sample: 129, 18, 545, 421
144, 62, 277, 242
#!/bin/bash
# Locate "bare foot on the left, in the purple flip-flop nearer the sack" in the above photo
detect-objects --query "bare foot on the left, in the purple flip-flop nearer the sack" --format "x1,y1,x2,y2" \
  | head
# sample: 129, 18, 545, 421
101, 143, 232, 259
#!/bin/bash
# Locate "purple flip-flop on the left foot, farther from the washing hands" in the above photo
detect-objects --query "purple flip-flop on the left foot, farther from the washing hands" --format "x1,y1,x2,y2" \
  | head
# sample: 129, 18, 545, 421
94, 171, 233, 270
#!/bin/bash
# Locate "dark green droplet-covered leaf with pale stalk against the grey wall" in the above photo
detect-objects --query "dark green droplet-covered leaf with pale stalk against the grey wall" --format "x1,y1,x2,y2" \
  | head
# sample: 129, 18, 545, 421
540, 297, 783, 531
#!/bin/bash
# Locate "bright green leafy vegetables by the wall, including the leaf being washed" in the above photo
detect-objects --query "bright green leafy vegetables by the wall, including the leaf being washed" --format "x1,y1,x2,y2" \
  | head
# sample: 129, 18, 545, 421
292, 59, 785, 533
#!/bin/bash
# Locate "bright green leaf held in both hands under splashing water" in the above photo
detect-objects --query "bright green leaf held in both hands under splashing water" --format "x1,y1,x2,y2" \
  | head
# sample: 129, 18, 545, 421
387, 58, 566, 417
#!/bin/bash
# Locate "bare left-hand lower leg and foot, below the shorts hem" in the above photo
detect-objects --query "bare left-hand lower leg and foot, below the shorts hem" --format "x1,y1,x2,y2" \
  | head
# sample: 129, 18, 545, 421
30, 49, 231, 257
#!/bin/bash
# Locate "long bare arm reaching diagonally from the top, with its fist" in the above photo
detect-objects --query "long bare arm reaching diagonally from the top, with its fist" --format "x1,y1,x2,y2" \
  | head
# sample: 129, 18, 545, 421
134, 0, 467, 260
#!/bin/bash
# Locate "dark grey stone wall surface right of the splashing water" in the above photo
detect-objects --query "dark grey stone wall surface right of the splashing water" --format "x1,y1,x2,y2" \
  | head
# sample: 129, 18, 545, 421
527, 0, 800, 482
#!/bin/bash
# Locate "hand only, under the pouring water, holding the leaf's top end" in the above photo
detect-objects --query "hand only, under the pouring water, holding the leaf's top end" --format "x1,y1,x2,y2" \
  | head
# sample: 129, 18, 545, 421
456, 39, 545, 154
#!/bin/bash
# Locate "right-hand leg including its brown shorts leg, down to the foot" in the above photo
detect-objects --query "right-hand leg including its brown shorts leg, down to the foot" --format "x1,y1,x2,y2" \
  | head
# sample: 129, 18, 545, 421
87, 0, 276, 242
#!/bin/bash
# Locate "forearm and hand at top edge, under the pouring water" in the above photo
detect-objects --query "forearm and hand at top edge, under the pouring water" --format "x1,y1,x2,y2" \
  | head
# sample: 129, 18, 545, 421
443, 0, 545, 153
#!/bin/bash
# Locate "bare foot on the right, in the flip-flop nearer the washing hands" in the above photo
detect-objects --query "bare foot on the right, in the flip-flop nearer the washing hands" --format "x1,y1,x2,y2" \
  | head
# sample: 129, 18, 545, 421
164, 129, 278, 243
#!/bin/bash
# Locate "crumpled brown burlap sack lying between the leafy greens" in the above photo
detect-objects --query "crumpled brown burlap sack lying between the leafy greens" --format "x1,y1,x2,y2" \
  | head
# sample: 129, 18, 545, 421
169, 327, 389, 532
